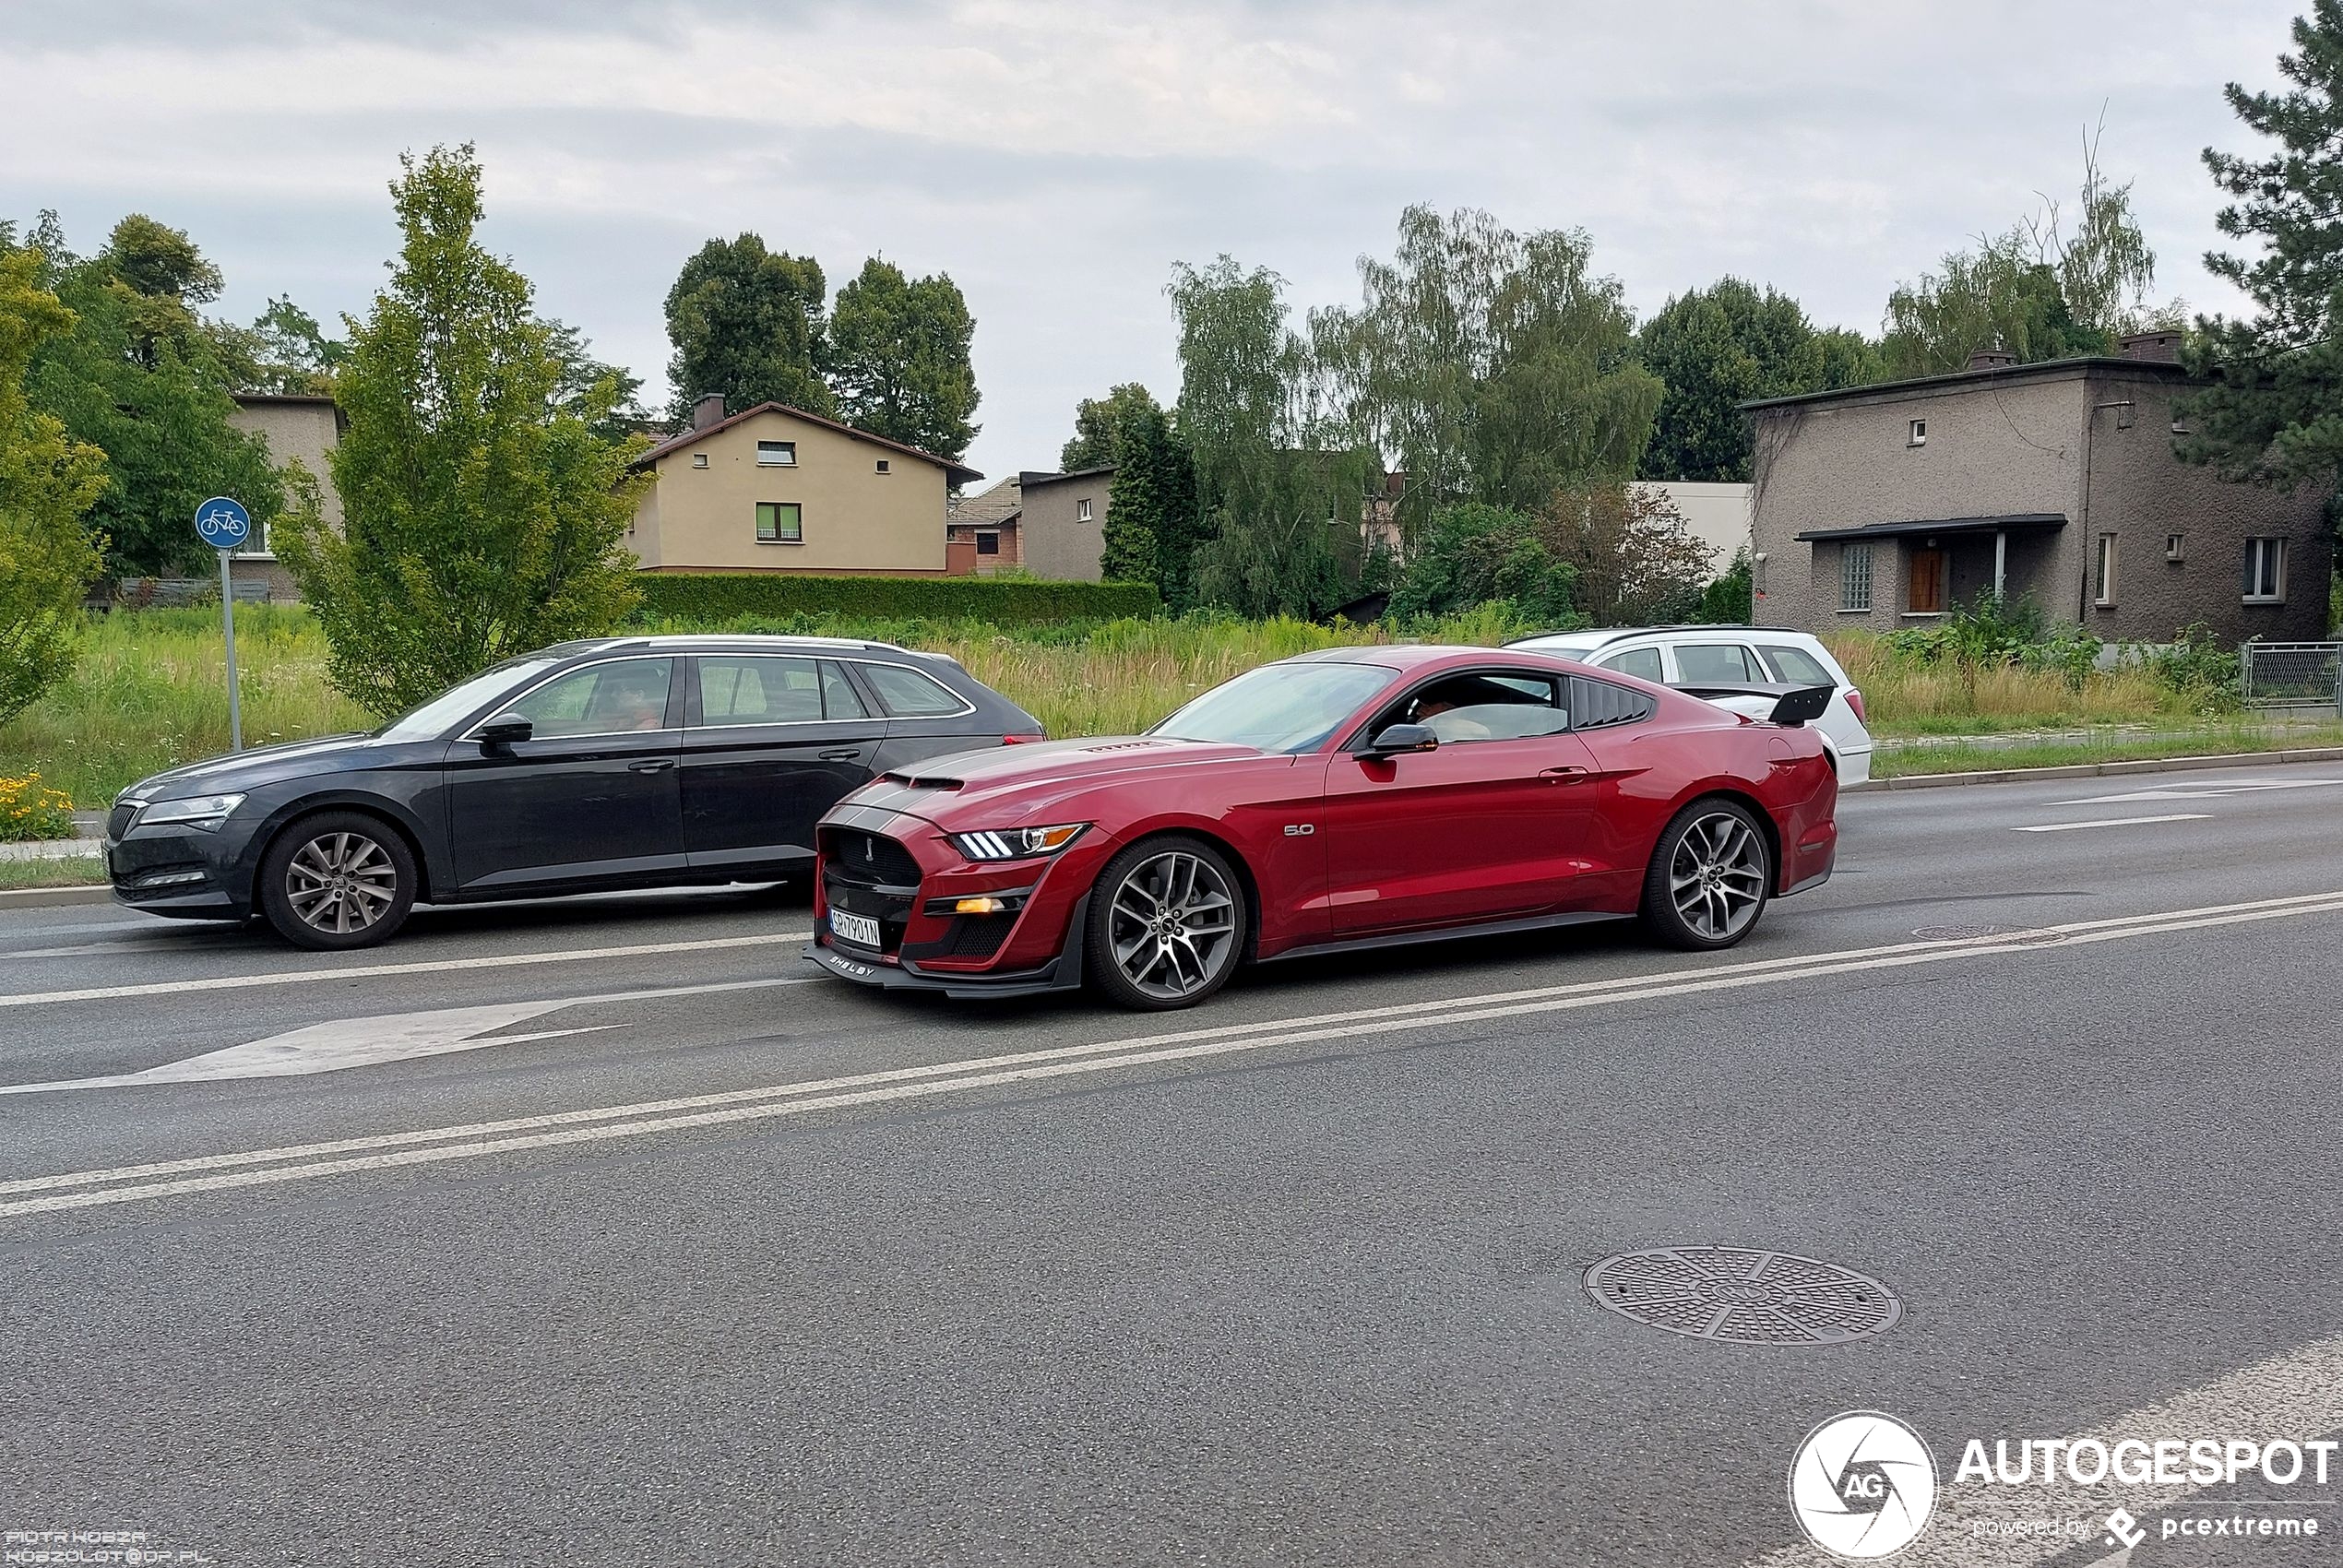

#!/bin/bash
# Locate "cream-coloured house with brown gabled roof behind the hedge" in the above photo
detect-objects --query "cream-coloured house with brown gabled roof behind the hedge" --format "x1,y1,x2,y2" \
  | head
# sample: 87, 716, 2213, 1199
625, 396, 984, 576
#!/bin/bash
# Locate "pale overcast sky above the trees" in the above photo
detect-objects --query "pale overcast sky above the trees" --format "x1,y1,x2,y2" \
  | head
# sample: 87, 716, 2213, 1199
0, 0, 2299, 476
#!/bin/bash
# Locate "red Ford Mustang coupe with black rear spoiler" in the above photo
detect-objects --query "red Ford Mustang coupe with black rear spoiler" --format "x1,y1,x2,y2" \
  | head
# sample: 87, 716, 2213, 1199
806, 647, 1839, 1008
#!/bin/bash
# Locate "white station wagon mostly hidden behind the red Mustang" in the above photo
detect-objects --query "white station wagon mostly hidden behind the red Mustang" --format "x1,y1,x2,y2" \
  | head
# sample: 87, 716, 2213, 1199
1506, 625, 1872, 785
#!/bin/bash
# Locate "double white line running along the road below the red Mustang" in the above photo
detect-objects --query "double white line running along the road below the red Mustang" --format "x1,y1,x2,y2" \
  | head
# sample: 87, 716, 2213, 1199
0, 891, 2343, 1218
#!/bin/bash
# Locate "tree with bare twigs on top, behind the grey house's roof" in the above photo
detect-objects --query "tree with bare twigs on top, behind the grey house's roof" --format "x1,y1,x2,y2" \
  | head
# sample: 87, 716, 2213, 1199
1882, 134, 2179, 377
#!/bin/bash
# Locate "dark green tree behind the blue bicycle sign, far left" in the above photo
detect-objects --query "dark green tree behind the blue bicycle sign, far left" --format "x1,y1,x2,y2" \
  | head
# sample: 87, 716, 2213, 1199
26, 216, 283, 575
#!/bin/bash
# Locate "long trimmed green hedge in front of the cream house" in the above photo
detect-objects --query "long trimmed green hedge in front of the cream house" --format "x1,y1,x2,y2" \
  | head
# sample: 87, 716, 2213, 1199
635, 572, 1162, 625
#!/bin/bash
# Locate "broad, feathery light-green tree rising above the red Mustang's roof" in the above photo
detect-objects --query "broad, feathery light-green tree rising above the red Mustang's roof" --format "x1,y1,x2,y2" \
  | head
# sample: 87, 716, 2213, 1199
1310, 207, 1661, 528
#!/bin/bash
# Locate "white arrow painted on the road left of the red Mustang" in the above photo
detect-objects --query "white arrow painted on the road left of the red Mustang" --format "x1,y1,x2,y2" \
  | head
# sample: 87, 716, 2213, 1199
0, 975, 813, 1095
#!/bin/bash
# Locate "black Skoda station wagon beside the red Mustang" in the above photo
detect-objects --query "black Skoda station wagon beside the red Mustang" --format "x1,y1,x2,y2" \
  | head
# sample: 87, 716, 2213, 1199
105, 637, 1041, 947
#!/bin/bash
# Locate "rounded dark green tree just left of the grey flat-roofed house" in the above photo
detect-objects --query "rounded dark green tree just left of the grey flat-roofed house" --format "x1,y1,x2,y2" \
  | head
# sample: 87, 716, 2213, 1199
1635, 277, 1877, 482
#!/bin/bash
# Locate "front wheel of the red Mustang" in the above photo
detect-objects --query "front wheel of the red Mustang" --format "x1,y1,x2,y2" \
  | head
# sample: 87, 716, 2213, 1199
1082, 835, 1246, 1010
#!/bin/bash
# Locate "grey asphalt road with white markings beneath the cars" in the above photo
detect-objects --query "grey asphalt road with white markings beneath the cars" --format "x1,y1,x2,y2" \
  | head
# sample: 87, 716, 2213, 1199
0, 764, 2343, 1568
